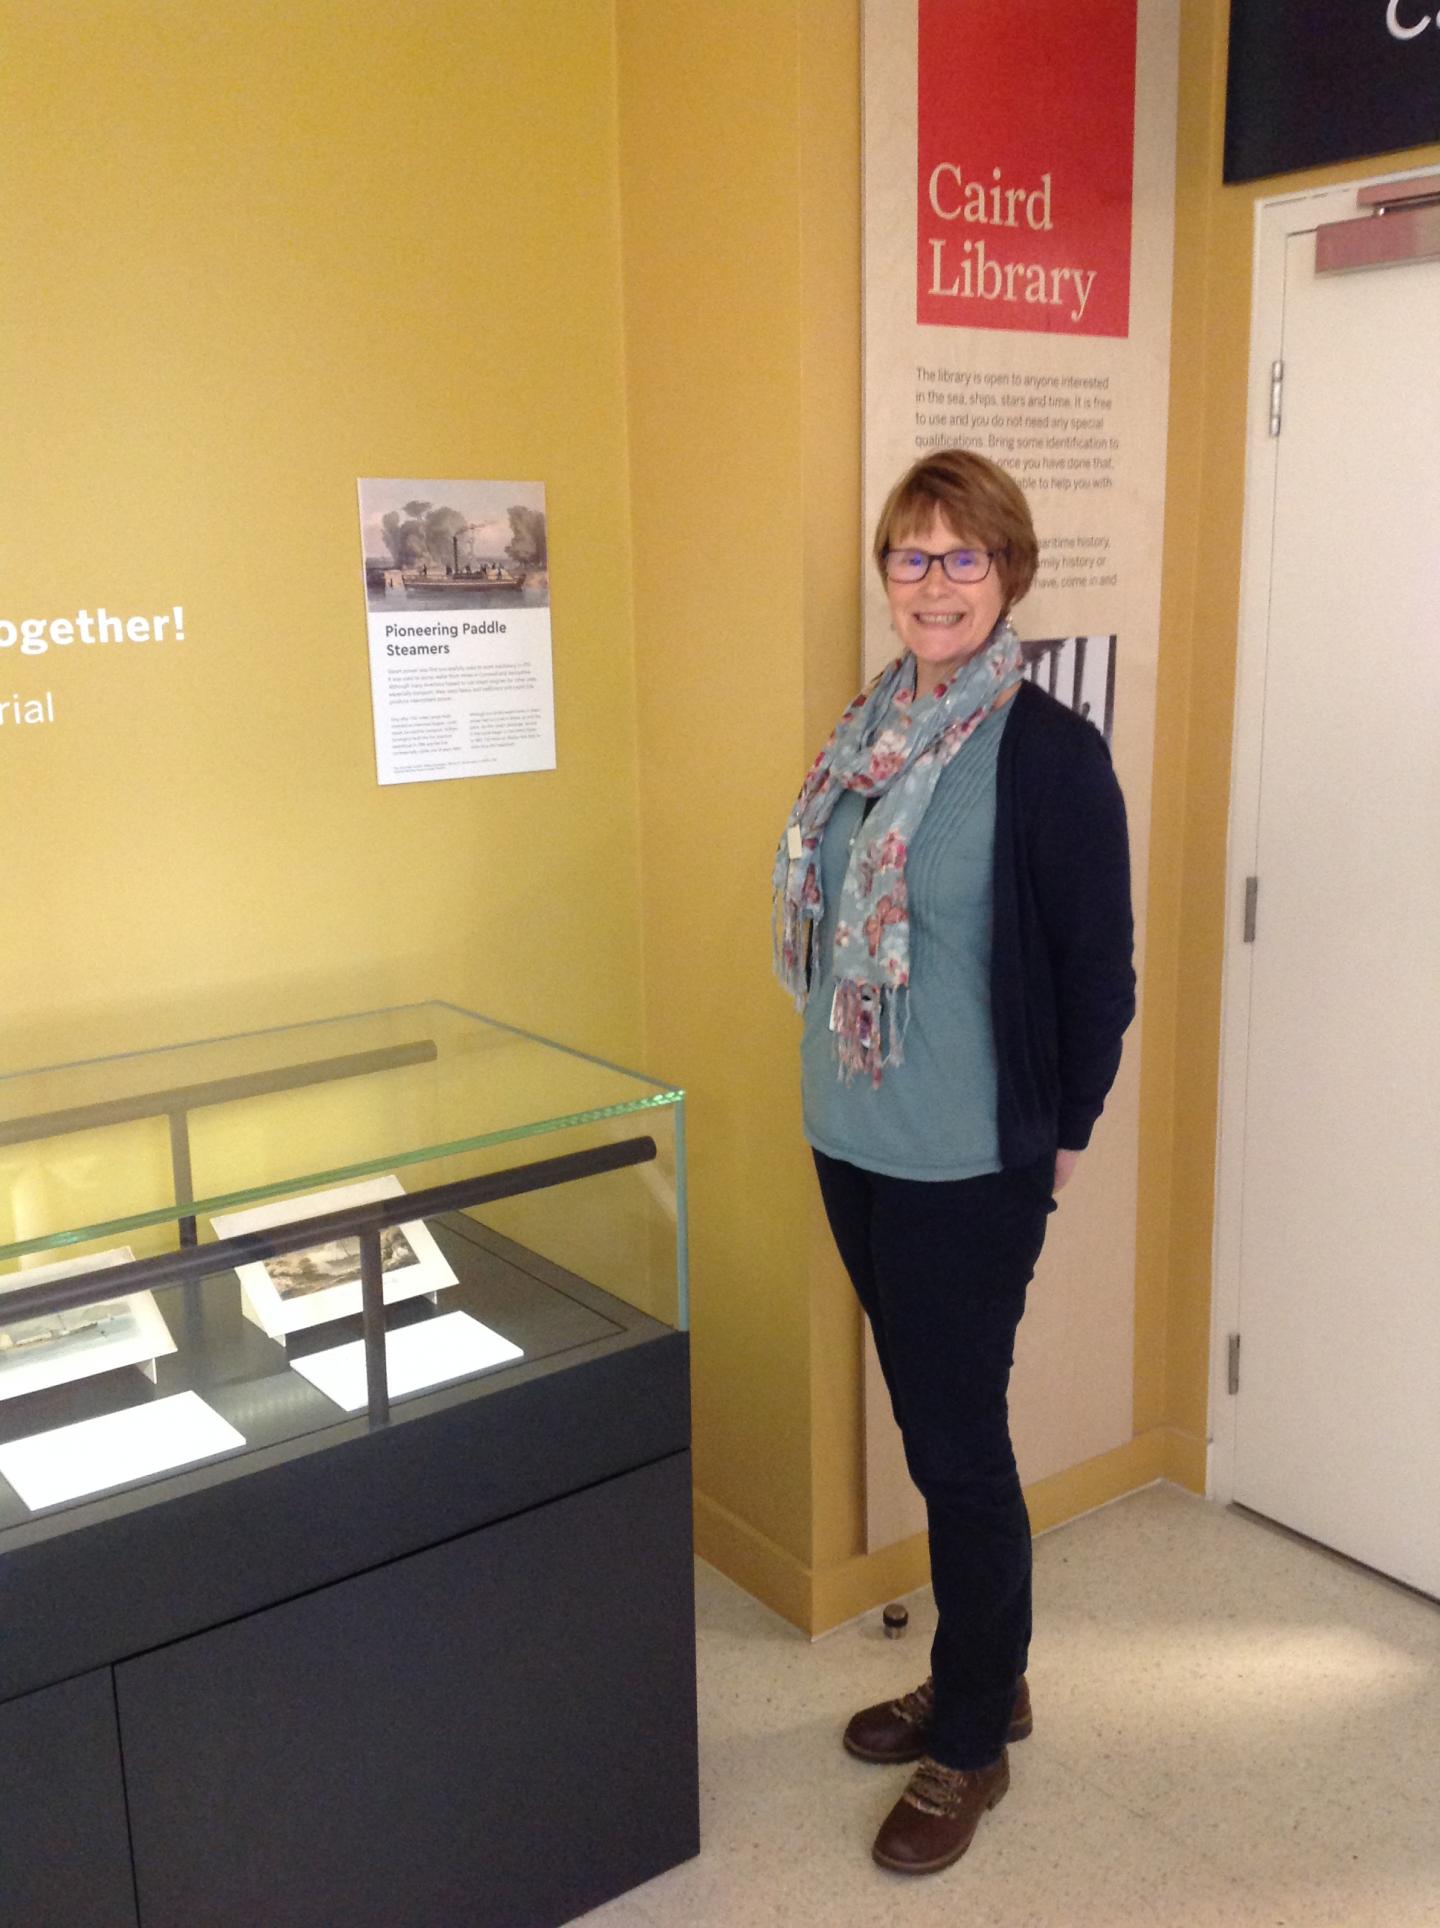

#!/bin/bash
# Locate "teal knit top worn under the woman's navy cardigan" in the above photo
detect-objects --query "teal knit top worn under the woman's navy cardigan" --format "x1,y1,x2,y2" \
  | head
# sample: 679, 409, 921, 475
800, 706, 1012, 1180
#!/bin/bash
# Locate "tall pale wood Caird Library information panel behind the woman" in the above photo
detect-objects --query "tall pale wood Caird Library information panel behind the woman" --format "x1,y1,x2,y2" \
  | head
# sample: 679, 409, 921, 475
864, 0, 1180, 1548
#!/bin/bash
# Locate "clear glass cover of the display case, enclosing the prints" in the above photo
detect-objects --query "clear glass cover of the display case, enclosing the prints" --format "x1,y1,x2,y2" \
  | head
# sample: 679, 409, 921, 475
0, 1003, 688, 1533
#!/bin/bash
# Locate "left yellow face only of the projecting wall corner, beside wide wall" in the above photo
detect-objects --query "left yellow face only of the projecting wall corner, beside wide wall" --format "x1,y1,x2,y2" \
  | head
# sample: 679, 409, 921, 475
617, 0, 810, 1619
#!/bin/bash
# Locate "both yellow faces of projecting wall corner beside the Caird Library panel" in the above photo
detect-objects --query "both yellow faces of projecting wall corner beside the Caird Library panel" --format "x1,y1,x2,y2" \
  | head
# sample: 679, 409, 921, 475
617, 0, 860, 1625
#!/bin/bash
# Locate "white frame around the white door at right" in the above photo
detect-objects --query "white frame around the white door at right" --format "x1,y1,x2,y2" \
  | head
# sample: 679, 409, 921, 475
1205, 168, 1436, 1504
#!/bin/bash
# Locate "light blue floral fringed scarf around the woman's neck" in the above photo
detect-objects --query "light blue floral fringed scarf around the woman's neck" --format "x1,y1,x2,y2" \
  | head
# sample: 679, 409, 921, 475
771, 617, 1020, 1085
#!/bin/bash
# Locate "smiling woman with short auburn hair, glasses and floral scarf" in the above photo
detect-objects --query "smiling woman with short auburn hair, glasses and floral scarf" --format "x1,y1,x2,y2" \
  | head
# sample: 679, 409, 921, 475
775, 449, 1135, 1874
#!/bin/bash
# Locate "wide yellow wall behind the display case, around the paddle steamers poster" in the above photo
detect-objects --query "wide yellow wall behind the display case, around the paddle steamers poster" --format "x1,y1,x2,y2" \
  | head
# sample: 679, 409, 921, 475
0, 0, 644, 1066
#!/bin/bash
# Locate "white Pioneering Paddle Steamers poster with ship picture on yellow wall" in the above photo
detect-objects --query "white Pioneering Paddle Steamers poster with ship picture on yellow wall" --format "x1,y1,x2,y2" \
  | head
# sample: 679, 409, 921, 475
360, 480, 555, 783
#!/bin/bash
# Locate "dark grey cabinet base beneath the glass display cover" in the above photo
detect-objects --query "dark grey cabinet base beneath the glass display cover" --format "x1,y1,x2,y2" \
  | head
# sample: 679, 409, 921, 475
0, 1218, 700, 1928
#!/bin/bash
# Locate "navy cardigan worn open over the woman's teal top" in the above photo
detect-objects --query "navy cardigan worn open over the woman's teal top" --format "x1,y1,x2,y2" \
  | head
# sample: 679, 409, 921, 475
991, 683, 1135, 1166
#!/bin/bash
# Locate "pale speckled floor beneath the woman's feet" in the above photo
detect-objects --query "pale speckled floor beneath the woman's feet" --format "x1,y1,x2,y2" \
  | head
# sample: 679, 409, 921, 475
584, 1486, 1440, 1928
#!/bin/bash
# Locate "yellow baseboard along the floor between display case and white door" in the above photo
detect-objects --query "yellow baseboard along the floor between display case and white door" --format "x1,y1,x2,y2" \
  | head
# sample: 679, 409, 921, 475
696, 1427, 1205, 1637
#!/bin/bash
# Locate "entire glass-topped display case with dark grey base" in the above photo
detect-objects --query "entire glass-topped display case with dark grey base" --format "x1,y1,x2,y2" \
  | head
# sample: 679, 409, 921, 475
0, 1003, 696, 1924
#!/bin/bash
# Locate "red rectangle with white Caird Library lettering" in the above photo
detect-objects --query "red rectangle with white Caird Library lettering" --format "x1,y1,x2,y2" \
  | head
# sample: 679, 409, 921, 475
916, 0, 1135, 335
